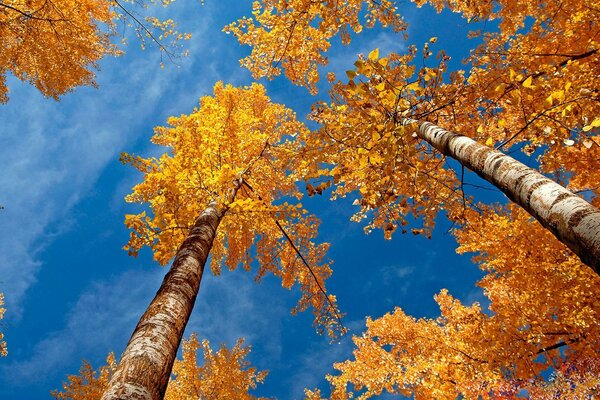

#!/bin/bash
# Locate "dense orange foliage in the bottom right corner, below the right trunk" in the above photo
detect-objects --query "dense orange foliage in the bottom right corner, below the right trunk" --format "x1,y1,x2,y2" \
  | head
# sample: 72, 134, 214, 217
307, 206, 600, 400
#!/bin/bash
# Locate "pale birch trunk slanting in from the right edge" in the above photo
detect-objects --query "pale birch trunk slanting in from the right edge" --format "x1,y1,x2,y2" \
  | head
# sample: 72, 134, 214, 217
404, 119, 600, 275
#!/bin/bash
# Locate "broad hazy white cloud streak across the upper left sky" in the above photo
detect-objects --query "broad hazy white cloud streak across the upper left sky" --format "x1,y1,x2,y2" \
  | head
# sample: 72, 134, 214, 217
0, 5, 220, 319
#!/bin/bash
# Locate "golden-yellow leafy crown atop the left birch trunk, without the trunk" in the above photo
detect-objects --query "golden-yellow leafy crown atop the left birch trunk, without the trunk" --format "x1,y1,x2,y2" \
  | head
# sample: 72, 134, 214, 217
124, 83, 341, 336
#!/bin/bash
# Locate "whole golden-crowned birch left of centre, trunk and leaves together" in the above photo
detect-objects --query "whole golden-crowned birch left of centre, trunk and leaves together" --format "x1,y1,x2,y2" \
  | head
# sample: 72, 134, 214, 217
102, 83, 342, 399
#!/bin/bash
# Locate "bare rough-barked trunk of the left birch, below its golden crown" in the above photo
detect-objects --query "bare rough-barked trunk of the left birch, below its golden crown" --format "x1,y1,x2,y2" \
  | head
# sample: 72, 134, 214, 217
102, 203, 222, 400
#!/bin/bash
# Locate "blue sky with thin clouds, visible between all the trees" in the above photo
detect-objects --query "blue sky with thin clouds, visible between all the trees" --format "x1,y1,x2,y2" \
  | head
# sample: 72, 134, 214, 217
0, 0, 506, 400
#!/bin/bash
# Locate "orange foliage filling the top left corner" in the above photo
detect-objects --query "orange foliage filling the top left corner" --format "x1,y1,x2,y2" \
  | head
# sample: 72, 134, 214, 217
0, 0, 189, 103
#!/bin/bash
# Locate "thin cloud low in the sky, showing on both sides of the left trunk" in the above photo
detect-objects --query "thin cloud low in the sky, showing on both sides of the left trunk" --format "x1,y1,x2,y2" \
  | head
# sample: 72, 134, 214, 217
0, 267, 289, 396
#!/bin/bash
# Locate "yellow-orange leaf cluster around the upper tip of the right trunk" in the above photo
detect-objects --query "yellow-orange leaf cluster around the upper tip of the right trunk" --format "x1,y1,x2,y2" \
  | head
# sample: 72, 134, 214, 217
298, 47, 462, 238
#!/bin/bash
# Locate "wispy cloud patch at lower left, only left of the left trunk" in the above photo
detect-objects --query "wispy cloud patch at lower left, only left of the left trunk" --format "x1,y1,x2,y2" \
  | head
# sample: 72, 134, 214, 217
0, 268, 165, 393
